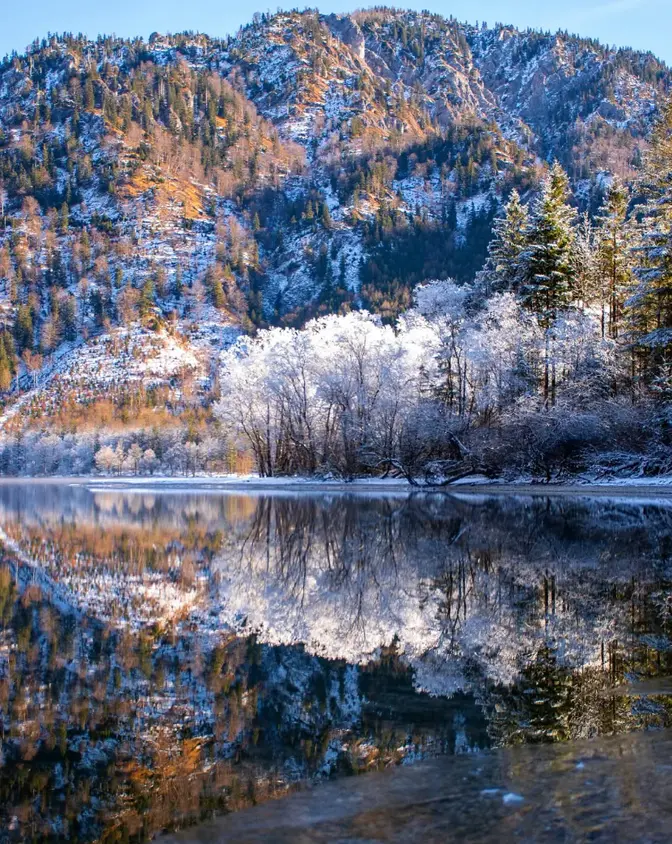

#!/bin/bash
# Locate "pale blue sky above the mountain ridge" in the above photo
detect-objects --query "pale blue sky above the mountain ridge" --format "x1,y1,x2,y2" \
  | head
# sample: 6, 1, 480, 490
0, 0, 672, 64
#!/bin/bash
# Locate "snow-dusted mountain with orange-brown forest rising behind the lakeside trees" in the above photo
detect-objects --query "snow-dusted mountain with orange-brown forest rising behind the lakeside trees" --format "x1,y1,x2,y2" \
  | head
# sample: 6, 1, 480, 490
0, 8, 672, 448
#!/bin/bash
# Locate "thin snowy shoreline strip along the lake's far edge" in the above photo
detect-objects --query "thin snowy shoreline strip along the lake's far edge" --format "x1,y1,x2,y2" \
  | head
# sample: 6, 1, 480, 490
0, 475, 672, 498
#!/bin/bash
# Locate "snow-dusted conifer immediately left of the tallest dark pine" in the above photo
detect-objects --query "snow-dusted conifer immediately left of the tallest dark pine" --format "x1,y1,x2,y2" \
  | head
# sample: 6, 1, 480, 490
479, 190, 529, 295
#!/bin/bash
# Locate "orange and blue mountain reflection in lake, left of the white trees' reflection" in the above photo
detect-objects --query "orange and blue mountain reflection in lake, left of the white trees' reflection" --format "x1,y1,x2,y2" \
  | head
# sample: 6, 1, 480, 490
0, 487, 488, 844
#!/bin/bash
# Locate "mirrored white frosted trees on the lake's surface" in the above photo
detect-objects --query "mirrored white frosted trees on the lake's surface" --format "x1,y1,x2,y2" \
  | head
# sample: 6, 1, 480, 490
217, 496, 670, 708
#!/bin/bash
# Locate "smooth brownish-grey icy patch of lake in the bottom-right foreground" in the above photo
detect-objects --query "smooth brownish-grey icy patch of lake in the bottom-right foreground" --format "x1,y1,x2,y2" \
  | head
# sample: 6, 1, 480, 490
160, 730, 672, 844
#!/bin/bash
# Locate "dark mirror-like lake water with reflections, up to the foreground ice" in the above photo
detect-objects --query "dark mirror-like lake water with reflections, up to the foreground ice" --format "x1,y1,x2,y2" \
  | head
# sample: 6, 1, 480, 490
0, 484, 672, 842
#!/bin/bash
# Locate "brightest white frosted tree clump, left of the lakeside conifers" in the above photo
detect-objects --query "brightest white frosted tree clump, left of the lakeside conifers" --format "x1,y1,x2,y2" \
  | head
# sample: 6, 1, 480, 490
216, 313, 435, 476
